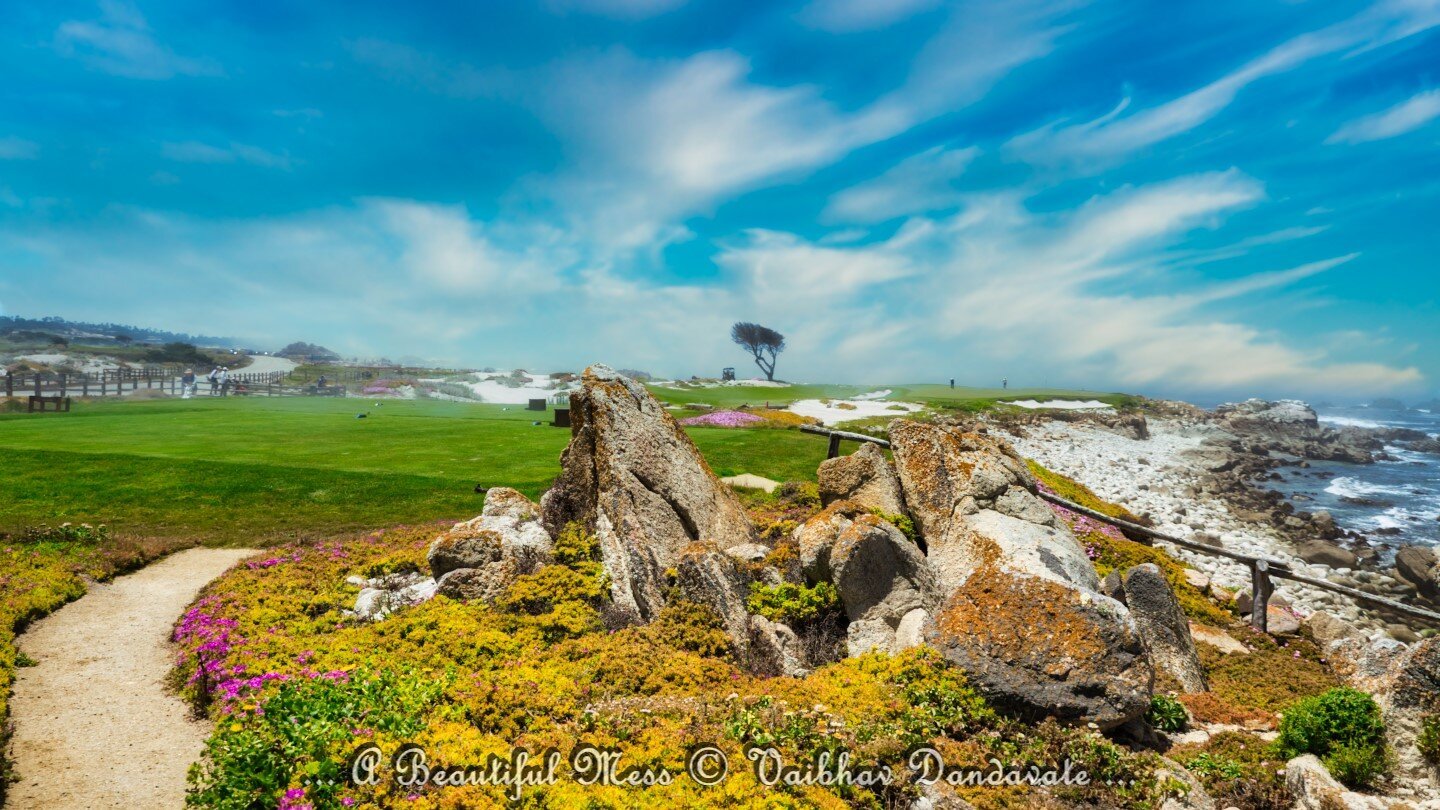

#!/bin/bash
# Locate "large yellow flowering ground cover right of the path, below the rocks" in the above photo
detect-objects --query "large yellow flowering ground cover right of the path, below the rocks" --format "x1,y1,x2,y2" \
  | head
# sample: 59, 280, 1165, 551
174, 513, 1174, 810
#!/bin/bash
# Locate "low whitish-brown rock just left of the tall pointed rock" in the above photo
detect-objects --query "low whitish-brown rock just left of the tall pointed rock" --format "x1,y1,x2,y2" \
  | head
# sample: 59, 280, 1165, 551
426, 487, 553, 601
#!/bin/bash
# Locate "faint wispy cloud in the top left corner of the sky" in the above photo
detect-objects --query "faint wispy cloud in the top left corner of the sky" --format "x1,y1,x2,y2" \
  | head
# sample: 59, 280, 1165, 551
55, 0, 222, 79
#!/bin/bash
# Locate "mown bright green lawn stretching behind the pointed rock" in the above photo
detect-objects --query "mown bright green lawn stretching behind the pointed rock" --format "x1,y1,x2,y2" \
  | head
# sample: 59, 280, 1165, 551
0, 398, 825, 543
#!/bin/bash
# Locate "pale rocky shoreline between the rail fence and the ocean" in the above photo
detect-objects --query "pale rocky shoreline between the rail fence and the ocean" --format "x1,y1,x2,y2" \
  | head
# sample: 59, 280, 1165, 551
998, 399, 1440, 641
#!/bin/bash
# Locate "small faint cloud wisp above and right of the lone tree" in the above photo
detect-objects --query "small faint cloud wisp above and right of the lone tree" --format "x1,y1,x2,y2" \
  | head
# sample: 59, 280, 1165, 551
821, 147, 979, 222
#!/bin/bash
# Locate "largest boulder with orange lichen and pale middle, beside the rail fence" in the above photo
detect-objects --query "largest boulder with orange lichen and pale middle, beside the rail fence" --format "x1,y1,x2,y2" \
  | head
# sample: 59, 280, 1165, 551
890, 421, 1153, 728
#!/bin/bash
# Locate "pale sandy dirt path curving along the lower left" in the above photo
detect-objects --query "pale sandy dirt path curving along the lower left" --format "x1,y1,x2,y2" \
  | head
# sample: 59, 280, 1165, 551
9, 549, 255, 810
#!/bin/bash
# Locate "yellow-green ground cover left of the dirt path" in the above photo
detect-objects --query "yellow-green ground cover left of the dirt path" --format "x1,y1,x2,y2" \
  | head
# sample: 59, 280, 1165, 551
0, 525, 187, 803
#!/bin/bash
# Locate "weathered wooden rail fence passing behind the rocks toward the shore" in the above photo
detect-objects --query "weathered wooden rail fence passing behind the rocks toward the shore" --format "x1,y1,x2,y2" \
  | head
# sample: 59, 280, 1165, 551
801, 425, 1440, 631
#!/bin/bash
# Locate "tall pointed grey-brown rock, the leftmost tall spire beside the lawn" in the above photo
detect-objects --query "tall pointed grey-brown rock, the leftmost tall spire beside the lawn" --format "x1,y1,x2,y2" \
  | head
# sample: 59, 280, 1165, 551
541, 365, 753, 621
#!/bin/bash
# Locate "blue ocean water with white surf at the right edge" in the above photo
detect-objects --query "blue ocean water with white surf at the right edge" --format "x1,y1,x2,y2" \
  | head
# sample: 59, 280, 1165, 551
1273, 408, 1440, 549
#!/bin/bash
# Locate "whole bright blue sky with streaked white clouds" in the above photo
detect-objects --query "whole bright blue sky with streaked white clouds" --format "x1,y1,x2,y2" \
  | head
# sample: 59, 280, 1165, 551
0, 0, 1440, 399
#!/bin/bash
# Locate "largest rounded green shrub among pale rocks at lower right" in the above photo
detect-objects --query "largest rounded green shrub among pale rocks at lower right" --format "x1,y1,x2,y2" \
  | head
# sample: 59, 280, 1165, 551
1276, 686, 1387, 787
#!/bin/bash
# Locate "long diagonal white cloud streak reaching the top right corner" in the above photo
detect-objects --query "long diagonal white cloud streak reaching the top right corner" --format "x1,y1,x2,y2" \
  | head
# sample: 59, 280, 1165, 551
1007, 0, 1440, 170
